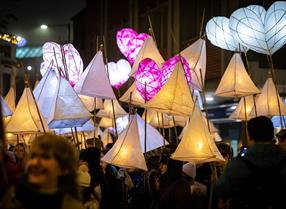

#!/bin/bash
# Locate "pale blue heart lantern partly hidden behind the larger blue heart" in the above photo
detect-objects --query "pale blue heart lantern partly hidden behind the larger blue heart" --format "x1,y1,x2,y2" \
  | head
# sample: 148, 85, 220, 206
206, 17, 247, 52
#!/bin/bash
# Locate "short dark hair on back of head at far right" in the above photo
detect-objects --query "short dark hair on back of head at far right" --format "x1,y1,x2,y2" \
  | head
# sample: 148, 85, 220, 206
247, 116, 274, 142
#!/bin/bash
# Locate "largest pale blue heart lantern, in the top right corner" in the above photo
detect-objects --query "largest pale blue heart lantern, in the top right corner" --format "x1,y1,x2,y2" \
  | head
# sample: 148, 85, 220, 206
229, 1, 286, 55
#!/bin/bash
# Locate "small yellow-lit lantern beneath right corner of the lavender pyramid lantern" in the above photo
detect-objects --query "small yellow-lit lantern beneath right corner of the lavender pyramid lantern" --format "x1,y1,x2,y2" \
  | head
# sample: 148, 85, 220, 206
96, 99, 128, 118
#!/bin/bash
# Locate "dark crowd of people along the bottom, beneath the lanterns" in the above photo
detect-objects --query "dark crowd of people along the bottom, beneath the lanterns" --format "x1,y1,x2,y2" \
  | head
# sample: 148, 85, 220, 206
0, 110, 286, 209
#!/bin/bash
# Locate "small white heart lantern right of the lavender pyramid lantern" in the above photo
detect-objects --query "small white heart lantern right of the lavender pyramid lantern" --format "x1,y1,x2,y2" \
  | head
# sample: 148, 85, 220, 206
106, 59, 131, 89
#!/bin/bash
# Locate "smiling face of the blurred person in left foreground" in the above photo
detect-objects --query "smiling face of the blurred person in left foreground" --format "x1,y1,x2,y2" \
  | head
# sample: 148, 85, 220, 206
27, 147, 62, 192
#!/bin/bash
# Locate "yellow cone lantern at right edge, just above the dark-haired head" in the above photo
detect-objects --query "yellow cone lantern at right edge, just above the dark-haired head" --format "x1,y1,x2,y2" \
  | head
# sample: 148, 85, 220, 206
250, 78, 286, 117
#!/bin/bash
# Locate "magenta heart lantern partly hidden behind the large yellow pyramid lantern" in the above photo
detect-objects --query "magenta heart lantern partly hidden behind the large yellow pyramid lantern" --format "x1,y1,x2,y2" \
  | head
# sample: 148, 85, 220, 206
134, 55, 192, 101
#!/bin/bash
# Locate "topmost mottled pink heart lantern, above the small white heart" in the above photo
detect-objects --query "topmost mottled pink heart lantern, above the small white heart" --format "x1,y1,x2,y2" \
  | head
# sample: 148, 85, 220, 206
116, 28, 150, 64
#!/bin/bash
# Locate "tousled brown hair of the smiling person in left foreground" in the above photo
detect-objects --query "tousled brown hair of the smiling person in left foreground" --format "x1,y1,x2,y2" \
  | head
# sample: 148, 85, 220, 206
32, 134, 80, 199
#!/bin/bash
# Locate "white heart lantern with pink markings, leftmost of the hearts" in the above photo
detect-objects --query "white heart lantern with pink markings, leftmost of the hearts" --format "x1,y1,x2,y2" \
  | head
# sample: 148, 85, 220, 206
41, 42, 83, 86
